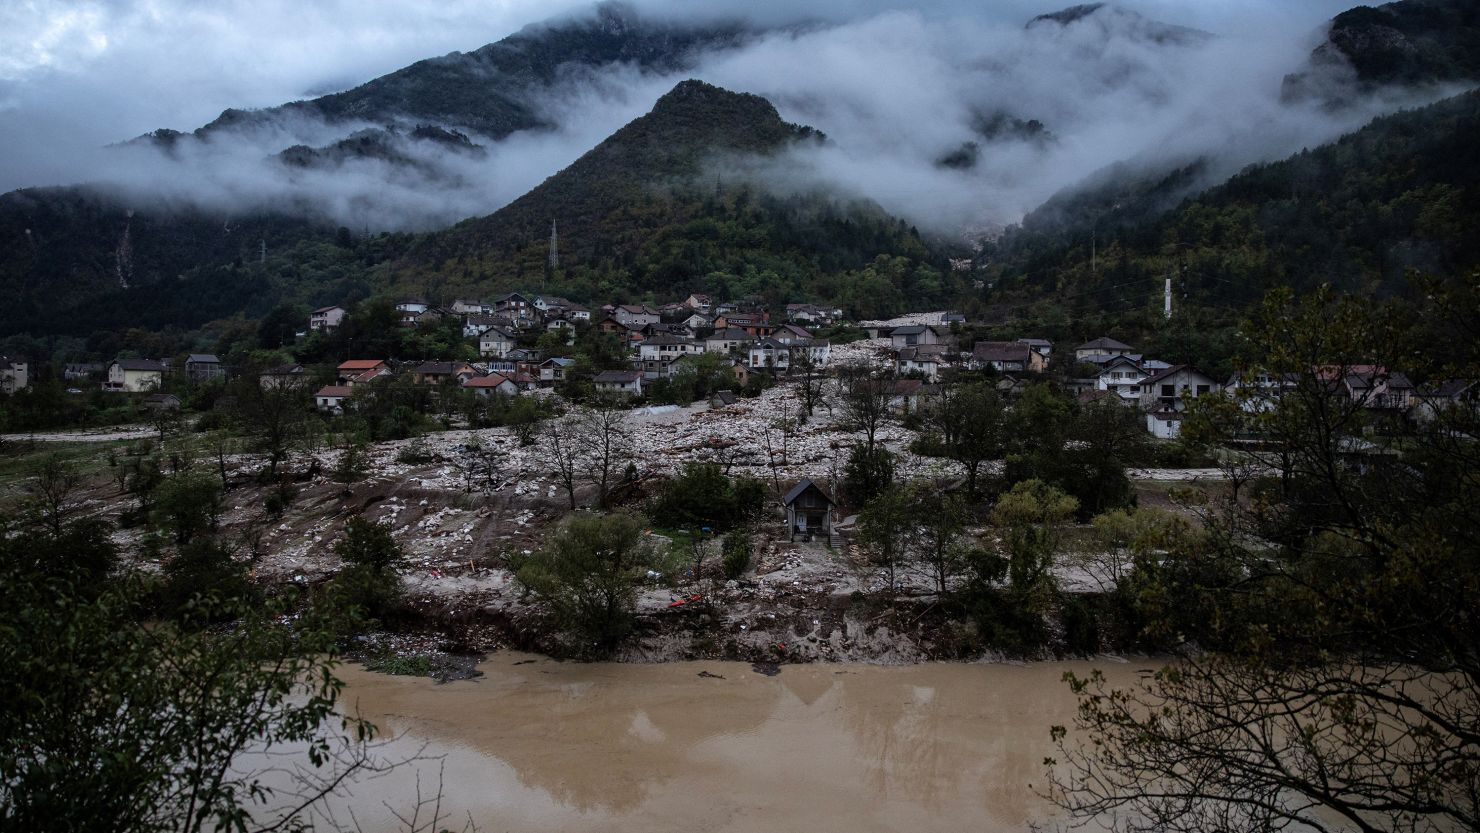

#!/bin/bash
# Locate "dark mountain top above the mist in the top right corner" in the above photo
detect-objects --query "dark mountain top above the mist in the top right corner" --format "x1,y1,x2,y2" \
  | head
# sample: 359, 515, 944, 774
1283, 0, 1480, 105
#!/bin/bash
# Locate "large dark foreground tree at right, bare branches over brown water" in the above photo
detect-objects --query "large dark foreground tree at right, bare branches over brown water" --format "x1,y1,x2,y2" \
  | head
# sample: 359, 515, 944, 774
1051, 291, 1480, 832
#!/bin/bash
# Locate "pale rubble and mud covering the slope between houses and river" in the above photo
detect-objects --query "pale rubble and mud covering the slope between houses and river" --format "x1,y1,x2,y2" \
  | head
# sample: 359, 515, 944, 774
4, 342, 1217, 675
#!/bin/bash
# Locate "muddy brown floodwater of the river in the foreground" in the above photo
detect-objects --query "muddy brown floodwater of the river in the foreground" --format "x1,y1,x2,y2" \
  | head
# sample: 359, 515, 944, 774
309, 652, 1153, 833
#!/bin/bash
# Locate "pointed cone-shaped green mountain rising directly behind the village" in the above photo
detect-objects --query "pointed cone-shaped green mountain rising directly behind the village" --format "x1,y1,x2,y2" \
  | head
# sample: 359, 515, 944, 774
381, 80, 931, 313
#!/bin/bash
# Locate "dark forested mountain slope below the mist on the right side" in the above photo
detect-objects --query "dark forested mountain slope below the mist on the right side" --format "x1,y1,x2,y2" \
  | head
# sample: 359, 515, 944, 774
990, 92, 1480, 306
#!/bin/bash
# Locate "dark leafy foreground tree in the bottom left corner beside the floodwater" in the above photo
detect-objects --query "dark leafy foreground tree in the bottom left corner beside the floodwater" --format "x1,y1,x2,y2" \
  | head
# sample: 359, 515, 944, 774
0, 526, 373, 833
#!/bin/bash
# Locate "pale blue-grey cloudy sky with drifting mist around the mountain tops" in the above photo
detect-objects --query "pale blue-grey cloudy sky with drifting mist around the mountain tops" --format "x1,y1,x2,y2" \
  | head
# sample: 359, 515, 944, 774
0, 0, 1385, 233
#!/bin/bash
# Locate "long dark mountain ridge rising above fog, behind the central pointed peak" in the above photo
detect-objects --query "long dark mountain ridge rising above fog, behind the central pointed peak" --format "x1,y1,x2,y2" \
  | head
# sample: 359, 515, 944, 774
149, 1, 758, 141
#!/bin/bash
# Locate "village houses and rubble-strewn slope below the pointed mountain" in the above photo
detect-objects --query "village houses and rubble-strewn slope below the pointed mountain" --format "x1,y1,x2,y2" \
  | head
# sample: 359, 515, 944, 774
4, 287, 1467, 671
